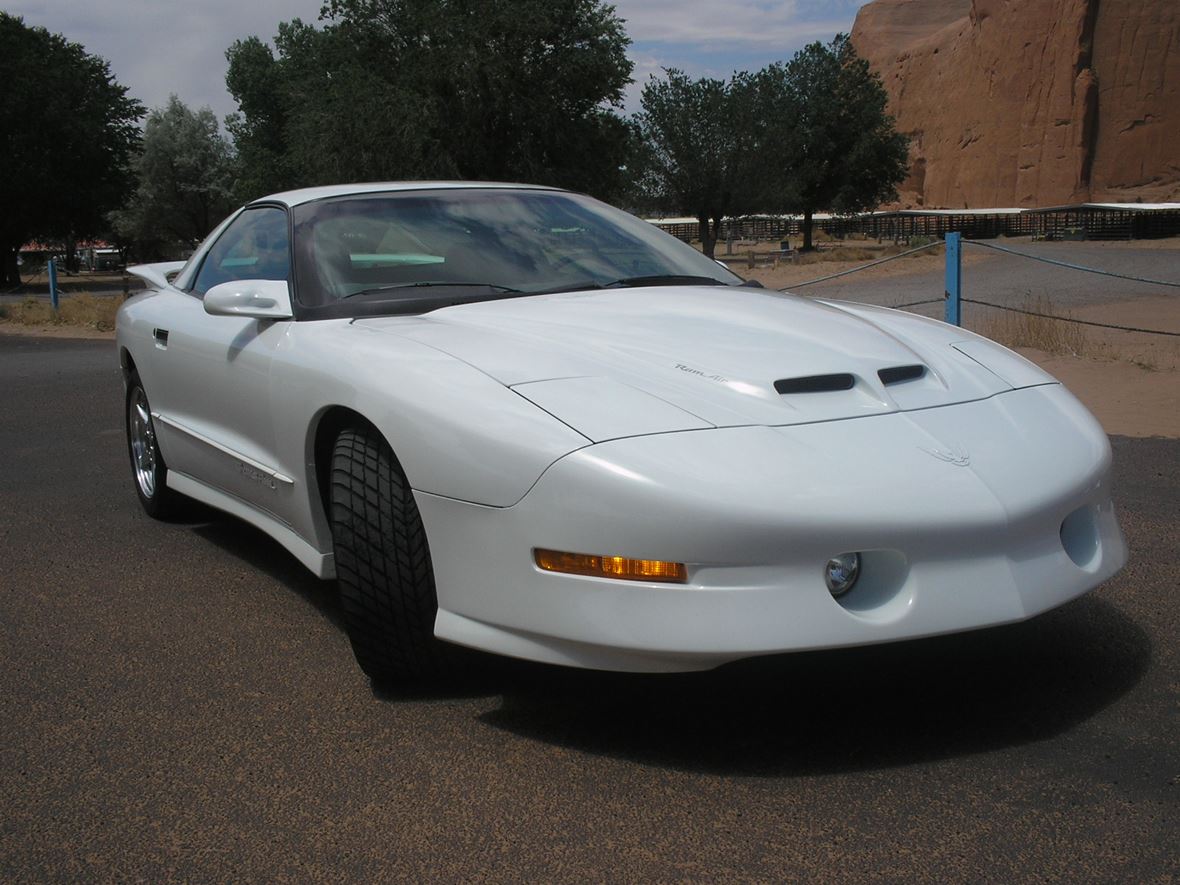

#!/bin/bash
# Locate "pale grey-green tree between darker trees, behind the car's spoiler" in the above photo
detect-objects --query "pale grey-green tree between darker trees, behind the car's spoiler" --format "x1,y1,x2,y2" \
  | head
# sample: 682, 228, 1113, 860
111, 96, 234, 254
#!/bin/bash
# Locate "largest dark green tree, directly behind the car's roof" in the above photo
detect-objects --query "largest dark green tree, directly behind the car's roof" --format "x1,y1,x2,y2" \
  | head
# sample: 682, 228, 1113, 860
227, 0, 631, 202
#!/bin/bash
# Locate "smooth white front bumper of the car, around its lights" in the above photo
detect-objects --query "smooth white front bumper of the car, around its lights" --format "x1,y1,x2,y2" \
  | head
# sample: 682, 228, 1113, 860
418, 385, 1126, 671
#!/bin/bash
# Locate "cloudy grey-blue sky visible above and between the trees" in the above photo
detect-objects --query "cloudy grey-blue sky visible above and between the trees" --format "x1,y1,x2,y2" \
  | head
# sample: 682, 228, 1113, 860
9, 0, 866, 125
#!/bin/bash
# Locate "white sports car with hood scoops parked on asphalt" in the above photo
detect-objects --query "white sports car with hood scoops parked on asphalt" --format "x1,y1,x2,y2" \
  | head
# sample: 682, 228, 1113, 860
118, 183, 1126, 682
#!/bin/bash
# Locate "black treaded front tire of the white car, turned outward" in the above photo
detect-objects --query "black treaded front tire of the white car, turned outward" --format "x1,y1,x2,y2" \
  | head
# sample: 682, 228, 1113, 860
329, 427, 458, 687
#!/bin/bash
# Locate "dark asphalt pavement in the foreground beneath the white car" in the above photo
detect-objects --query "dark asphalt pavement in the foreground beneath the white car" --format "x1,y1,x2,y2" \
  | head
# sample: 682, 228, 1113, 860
0, 336, 1180, 881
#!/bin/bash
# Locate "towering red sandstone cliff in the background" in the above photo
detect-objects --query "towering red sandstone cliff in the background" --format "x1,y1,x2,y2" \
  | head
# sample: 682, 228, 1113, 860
852, 0, 1180, 208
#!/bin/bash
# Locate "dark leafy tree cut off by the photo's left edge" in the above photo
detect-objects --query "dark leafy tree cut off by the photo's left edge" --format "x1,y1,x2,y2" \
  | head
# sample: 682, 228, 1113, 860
0, 12, 143, 287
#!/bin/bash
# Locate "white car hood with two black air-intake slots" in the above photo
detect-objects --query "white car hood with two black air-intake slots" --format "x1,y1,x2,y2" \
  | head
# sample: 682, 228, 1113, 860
356, 287, 1053, 441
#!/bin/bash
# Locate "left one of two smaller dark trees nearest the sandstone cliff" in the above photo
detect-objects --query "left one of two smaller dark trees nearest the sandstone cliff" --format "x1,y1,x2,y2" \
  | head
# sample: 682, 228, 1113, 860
636, 68, 754, 257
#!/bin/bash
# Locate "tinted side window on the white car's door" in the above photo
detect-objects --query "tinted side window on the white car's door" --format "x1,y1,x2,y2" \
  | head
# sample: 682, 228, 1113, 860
192, 207, 291, 295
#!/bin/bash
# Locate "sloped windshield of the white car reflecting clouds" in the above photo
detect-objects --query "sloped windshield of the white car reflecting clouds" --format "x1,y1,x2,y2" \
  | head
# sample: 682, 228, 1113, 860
293, 188, 742, 317
